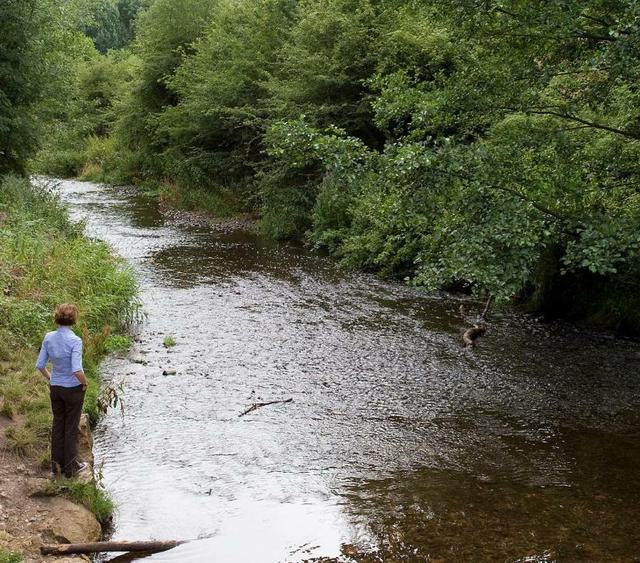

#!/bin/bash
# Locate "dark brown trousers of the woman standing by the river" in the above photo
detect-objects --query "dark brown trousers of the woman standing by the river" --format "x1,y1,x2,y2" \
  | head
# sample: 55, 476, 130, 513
50, 385, 84, 477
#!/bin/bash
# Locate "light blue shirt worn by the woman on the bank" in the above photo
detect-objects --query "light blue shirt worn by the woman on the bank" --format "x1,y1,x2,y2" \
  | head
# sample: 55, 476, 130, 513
36, 326, 82, 387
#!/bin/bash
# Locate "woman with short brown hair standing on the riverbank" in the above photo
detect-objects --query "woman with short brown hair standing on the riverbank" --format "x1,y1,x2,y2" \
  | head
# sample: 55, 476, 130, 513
36, 303, 87, 478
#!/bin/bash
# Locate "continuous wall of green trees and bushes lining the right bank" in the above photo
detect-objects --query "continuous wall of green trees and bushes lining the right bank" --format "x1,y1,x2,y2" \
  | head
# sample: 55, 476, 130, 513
27, 0, 640, 327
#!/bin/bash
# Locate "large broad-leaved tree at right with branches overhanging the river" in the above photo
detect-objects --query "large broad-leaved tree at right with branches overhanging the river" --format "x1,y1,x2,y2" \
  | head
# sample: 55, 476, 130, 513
269, 1, 640, 318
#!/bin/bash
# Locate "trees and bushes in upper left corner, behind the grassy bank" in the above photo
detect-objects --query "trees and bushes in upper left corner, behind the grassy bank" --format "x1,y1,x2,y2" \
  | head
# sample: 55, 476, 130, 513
0, 0, 142, 175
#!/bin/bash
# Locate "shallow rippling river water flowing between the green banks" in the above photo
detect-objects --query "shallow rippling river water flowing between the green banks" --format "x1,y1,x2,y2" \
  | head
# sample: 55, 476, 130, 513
58, 181, 640, 562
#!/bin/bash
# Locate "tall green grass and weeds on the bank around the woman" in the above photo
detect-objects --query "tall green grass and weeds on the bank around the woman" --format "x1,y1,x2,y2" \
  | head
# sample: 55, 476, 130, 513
0, 177, 137, 519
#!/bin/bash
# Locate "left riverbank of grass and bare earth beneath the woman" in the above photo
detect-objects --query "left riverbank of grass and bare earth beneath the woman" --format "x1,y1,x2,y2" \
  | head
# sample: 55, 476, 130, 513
0, 177, 137, 563
